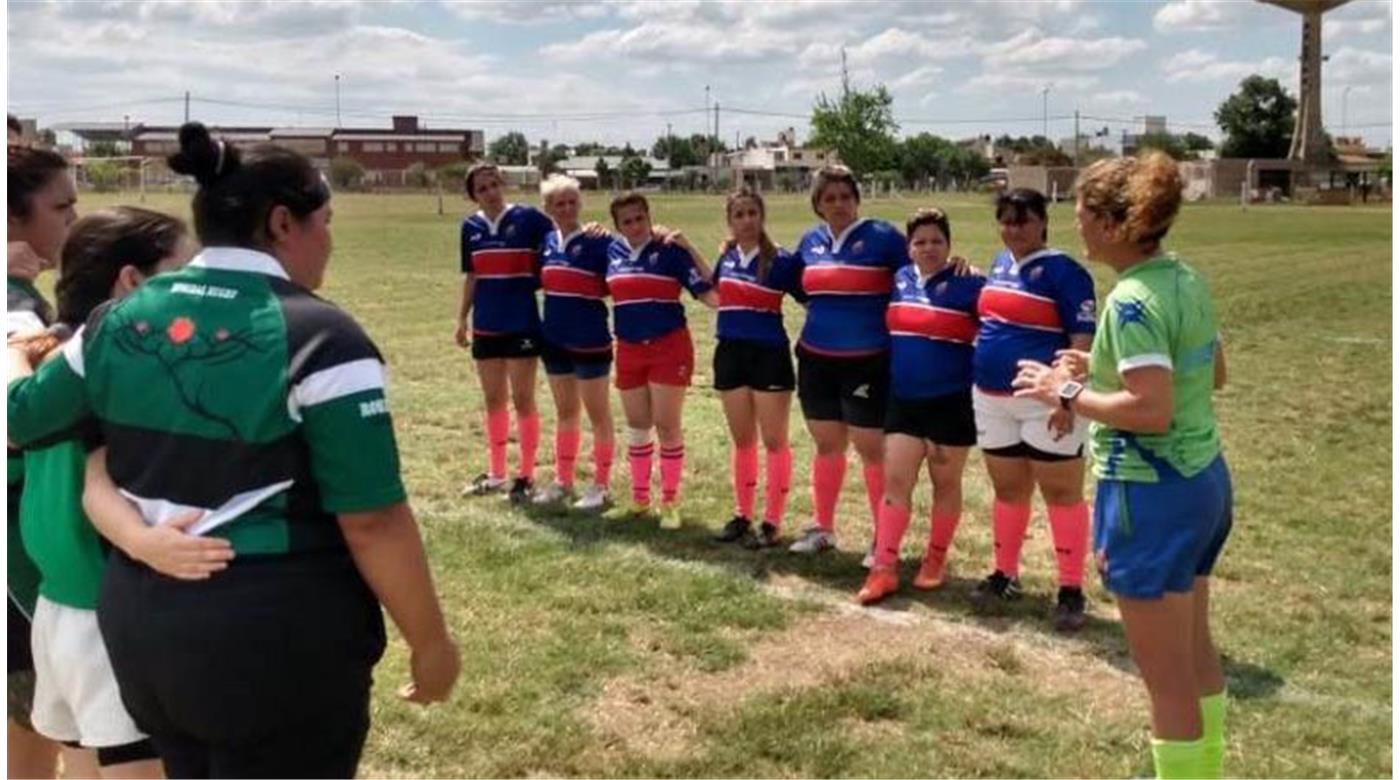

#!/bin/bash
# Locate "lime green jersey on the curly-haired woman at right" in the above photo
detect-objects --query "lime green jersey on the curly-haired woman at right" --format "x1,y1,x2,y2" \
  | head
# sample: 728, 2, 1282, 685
1089, 253, 1221, 482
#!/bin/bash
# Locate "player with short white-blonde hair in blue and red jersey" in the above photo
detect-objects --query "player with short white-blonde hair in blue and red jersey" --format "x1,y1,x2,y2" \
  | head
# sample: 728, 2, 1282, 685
535, 174, 613, 510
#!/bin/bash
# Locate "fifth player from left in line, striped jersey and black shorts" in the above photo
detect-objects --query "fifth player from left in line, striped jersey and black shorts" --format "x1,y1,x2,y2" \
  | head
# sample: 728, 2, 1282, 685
788, 165, 909, 553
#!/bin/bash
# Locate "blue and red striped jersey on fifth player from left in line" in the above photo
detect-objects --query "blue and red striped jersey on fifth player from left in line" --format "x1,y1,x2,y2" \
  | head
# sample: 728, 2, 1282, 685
797, 220, 909, 356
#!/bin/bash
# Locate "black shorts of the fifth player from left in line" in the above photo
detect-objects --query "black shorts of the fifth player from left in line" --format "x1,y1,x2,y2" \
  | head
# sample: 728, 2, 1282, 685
797, 344, 889, 429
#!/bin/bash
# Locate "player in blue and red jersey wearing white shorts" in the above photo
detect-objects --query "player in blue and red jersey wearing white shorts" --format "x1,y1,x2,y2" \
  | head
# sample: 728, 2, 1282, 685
973, 189, 1095, 630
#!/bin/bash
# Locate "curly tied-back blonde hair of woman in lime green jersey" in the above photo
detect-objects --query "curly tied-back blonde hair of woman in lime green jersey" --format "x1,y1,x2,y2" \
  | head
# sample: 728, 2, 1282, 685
1074, 151, 1184, 249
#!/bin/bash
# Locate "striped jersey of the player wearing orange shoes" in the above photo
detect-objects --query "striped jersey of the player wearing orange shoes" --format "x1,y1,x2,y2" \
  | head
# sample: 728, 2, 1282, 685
885, 263, 987, 401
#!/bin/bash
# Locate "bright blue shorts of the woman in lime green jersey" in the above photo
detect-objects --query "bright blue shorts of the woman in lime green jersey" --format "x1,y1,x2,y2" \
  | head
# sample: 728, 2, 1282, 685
1093, 457, 1233, 598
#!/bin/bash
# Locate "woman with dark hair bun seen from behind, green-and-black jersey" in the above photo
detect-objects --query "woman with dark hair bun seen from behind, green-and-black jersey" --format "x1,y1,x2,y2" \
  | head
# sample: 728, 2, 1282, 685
8, 123, 458, 777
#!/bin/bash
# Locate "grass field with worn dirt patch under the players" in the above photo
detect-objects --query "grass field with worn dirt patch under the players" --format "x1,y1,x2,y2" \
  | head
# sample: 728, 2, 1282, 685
80, 195, 1392, 777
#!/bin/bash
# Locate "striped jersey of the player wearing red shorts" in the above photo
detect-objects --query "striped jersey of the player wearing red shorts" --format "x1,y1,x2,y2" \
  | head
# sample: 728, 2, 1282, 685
608, 238, 710, 342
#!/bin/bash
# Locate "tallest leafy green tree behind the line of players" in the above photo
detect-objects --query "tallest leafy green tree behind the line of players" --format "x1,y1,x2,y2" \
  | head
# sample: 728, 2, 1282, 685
811, 84, 899, 176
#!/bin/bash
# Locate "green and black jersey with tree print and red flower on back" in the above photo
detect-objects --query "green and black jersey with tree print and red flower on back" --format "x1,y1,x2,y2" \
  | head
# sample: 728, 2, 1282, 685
8, 246, 405, 555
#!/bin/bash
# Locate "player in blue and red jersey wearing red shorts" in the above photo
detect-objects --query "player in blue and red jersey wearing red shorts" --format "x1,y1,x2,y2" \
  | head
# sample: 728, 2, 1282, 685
608, 192, 718, 531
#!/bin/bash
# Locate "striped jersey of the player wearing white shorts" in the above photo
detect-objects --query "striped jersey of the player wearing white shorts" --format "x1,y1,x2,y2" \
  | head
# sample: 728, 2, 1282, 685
973, 249, 1095, 394
